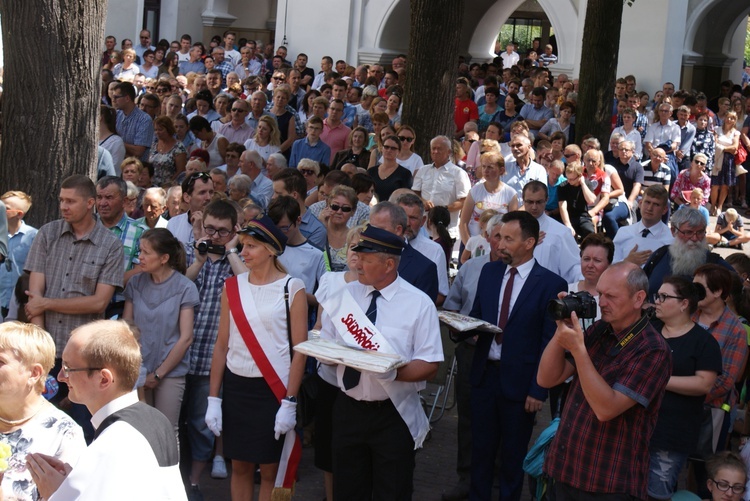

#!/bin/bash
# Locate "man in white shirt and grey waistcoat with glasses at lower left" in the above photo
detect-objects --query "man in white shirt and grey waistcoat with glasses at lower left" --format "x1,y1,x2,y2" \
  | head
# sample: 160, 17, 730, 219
27, 320, 187, 501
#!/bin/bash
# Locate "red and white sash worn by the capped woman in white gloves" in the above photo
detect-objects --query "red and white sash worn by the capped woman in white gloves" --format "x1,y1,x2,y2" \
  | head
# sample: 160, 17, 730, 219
225, 274, 302, 489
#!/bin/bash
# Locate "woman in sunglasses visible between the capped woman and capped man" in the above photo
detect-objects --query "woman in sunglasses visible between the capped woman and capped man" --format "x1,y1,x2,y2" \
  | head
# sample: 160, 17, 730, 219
320, 185, 359, 271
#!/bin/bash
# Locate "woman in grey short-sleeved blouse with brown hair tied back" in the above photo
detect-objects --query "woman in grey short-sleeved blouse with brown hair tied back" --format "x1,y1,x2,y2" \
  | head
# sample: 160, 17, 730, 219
123, 228, 200, 442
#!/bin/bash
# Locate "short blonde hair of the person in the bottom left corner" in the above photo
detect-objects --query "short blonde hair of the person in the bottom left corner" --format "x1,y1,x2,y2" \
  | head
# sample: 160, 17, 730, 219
0, 321, 55, 394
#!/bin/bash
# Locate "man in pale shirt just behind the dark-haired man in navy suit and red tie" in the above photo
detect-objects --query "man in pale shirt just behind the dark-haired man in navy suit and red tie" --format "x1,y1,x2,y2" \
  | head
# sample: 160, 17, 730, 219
523, 180, 581, 284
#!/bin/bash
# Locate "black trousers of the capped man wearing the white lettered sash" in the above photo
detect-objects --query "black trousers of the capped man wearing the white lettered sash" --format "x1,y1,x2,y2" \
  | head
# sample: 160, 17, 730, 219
333, 392, 414, 501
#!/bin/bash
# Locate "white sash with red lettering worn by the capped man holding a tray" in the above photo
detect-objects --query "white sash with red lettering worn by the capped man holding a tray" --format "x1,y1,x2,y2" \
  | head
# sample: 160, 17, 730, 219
321, 288, 430, 449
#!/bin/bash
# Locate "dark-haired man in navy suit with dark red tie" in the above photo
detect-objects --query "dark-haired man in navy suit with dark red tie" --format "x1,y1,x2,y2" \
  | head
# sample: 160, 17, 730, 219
470, 211, 567, 500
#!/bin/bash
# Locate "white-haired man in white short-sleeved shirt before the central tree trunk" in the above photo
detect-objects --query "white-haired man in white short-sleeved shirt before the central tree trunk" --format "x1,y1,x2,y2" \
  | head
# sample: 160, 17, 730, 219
411, 136, 471, 238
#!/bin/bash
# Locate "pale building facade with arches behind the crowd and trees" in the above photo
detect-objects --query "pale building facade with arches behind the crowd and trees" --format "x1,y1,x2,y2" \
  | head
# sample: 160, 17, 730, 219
106, 0, 750, 93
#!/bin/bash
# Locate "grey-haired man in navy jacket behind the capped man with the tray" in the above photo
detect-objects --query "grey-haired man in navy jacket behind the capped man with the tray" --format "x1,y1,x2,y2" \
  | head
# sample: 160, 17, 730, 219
370, 201, 440, 302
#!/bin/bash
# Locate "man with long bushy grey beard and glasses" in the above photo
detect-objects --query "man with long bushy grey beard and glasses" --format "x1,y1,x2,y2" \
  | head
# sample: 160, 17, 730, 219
643, 208, 734, 297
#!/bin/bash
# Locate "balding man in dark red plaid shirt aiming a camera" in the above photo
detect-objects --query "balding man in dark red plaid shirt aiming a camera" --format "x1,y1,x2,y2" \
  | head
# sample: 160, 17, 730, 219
537, 262, 672, 501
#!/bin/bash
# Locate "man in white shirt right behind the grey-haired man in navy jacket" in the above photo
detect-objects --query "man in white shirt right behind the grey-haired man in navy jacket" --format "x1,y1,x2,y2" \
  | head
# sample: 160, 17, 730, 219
396, 193, 449, 306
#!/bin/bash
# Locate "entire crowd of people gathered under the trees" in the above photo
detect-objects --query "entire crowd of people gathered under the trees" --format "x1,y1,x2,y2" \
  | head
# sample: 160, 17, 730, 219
0, 30, 750, 501
